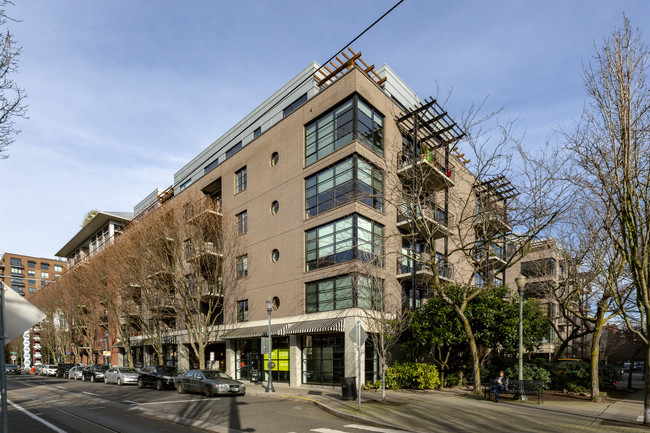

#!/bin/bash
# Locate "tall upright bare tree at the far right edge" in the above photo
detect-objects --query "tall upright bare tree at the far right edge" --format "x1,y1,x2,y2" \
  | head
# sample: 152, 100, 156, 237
565, 17, 650, 418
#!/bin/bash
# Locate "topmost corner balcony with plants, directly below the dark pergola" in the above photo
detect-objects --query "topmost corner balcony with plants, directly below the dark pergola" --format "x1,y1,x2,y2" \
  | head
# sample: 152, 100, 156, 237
397, 151, 456, 191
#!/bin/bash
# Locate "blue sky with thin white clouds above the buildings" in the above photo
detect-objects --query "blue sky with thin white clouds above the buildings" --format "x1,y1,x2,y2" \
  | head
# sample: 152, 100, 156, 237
0, 0, 650, 257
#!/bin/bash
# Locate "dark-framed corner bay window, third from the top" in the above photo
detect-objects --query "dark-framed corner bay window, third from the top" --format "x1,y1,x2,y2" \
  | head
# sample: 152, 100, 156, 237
305, 214, 384, 271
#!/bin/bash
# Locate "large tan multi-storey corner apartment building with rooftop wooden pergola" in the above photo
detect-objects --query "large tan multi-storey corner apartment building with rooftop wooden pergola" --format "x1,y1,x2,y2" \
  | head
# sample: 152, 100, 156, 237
57, 50, 512, 386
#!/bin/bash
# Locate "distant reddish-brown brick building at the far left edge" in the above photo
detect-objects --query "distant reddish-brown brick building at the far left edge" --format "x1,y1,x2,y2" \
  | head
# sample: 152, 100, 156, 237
0, 252, 68, 300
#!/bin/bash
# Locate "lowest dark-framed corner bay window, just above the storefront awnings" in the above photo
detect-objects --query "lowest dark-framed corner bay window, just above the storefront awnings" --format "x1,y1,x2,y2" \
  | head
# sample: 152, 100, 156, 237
305, 275, 382, 313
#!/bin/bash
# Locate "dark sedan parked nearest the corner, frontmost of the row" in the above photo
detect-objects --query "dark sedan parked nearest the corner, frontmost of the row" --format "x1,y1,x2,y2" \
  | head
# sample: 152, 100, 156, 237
174, 370, 246, 397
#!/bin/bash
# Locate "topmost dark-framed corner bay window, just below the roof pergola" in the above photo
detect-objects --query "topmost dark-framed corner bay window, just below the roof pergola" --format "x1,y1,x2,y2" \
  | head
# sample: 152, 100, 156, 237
305, 95, 384, 165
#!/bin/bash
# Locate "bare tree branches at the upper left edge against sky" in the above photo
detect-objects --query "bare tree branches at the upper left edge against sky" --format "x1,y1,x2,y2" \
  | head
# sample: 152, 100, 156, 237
0, 0, 27, 159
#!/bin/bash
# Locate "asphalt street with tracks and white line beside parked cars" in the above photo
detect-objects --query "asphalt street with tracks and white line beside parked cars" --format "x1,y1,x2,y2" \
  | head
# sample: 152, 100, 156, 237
7, 375, 400, 433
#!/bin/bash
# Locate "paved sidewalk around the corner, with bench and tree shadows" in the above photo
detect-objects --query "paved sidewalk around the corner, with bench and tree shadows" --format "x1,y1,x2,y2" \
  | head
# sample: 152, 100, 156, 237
247, 383, 650, 433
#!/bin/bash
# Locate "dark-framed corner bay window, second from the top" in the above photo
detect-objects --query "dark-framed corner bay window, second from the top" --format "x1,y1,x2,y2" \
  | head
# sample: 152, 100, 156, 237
305, 155, 384, 218
